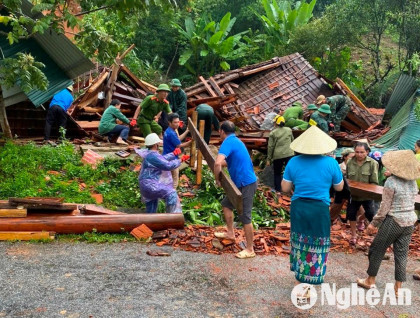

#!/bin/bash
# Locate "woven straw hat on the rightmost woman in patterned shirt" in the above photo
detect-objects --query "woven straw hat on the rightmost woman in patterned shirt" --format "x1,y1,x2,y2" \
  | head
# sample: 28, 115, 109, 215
382, 150, 420, 180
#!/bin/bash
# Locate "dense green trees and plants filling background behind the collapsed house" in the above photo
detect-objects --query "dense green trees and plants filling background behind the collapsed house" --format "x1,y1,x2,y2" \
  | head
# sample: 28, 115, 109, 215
0, 0, 420, 107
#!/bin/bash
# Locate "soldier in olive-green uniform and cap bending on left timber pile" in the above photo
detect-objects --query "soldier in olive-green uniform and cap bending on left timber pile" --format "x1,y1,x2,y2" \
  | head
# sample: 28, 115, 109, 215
137, 84, 172, 138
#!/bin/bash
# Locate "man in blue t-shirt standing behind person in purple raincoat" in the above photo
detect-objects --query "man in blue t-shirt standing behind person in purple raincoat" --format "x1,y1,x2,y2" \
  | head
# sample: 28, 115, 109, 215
163, 113, 191, 189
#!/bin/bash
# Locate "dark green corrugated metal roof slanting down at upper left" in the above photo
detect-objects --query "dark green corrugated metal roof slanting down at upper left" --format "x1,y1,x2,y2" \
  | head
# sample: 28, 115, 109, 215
0, 0, 94, 106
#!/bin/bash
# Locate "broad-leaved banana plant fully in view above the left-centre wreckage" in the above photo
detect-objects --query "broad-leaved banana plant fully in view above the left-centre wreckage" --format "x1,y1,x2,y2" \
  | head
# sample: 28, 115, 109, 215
177, 12, 250, 75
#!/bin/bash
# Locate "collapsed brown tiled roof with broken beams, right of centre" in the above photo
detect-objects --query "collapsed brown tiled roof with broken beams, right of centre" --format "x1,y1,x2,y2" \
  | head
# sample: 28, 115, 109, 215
185, 53, 381, 148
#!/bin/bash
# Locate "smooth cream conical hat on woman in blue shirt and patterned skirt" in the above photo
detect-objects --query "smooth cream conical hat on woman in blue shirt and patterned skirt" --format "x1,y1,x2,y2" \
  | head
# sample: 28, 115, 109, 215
290, 126, 337, 155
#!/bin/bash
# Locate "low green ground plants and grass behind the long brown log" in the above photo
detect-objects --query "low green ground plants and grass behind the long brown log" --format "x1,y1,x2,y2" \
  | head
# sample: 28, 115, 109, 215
0, 142, 287, 227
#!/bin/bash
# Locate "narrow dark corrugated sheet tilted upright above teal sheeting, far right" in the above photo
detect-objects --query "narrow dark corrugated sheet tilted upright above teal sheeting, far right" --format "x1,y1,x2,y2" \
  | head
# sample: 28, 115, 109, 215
385, 74, 417, 116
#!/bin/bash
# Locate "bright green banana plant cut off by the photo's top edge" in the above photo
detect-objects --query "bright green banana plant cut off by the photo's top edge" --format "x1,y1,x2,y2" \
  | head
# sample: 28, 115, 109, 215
254, 0, 316, 45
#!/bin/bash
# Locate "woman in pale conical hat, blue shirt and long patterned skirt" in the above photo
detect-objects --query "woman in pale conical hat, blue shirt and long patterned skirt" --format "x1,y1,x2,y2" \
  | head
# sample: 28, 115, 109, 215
281, 126, 344, 284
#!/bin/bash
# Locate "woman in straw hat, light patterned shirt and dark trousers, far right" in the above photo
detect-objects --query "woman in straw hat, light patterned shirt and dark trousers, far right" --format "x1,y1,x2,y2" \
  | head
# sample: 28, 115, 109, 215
357, 150, 420, 296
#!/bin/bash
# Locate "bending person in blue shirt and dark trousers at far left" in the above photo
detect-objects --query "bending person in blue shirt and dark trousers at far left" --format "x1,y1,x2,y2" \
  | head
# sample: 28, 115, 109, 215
44, 86, 74, 145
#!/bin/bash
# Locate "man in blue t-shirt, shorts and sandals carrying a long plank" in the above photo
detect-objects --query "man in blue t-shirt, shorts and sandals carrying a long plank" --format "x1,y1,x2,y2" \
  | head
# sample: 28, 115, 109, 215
214, 121, 257, 258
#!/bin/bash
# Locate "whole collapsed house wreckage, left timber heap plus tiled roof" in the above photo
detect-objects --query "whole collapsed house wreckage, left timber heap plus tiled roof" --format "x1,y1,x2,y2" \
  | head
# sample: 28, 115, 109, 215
68, 53, 381, 150
